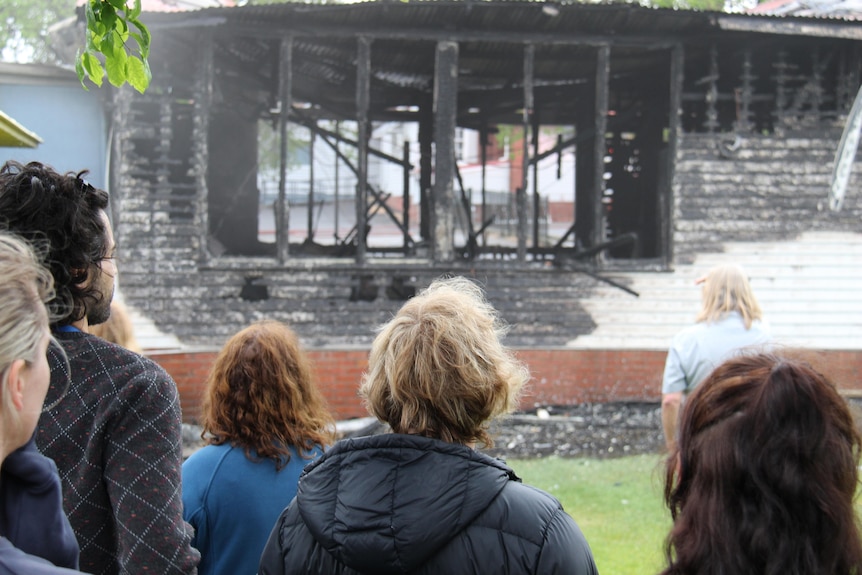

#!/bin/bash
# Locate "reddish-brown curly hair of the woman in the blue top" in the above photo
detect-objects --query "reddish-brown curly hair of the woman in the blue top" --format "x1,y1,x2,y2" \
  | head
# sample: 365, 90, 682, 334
201, 320, 335, 469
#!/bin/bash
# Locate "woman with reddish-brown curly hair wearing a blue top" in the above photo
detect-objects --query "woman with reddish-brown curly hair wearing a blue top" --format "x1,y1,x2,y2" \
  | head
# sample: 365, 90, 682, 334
183, 321, 335, 575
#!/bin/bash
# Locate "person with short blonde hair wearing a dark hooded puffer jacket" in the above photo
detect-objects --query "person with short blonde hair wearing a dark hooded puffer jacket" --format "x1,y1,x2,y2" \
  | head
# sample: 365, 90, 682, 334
259, 278, 596, 575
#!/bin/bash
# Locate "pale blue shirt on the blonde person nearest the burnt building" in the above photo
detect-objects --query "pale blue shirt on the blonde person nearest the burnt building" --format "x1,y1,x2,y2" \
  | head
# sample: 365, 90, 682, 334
661, 311, 772, 393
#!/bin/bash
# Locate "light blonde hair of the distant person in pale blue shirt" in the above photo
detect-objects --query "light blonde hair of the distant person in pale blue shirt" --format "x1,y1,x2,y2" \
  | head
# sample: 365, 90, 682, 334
696, 264, 763, 329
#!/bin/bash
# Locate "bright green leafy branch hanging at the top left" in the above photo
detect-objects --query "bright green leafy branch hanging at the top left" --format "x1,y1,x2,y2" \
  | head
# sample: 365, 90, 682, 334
75, 0, 152, 93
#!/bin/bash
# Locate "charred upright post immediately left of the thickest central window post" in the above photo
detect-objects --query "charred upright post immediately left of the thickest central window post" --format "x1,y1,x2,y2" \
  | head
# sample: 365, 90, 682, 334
356, 36, 371, 265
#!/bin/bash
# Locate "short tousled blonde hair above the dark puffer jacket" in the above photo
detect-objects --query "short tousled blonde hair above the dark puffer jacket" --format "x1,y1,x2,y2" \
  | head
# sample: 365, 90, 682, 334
359, 278, 530, 446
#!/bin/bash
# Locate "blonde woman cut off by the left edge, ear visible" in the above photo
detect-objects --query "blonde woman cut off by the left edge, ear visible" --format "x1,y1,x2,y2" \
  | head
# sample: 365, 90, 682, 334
0, 233, 78, 575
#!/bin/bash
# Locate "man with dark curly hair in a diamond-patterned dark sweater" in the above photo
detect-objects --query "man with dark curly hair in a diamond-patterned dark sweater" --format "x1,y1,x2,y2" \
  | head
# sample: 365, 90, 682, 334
0, 161, 199, 575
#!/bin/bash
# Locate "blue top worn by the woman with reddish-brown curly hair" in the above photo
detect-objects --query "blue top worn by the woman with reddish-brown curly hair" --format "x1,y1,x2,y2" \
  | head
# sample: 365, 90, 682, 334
183, 445, 323, 575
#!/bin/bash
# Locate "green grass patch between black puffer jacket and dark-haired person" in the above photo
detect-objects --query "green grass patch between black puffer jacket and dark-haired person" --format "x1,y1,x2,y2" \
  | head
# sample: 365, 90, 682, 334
508, 455, 671, 575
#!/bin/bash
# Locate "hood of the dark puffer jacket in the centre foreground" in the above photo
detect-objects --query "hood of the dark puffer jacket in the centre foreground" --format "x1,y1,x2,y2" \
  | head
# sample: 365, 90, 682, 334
296, 434, 520, 573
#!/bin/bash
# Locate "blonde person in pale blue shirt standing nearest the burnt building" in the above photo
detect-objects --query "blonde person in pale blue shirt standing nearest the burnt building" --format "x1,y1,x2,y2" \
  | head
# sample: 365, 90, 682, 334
661, 264, 772, 451
